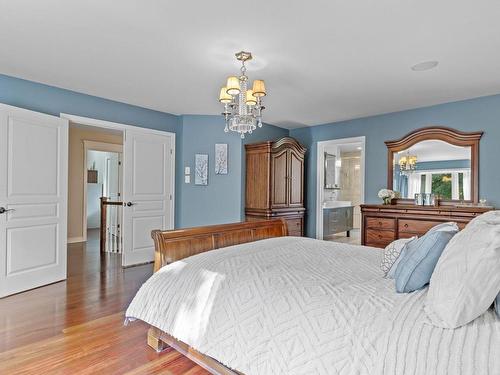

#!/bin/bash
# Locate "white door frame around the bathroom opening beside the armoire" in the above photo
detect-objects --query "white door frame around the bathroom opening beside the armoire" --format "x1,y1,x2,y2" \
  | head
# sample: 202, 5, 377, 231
316, 136, 366, 239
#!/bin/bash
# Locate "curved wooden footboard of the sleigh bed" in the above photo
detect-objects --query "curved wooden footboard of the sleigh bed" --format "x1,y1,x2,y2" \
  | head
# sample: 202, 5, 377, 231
151, 219, 288, 272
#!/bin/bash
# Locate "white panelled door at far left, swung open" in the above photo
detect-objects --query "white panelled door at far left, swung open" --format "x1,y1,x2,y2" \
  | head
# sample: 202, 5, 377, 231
0, 104, 68, 297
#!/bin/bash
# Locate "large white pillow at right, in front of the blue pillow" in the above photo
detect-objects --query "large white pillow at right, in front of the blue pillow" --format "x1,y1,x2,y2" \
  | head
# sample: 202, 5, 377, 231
425, 217, 500, 328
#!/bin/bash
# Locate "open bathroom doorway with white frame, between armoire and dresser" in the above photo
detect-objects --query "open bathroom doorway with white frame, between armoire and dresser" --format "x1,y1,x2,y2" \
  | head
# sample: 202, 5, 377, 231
316, 137, 365, 244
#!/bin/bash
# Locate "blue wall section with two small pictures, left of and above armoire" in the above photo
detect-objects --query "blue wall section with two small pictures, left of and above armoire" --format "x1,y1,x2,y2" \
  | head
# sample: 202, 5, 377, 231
178, 115, 288, 228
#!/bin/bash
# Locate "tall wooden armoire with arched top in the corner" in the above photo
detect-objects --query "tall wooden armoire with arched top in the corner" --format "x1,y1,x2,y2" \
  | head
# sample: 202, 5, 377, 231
245, 137, 306, 236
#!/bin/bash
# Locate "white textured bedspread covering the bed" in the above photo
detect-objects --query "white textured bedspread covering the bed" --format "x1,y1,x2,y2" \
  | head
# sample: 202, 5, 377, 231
126, 237, 500, 375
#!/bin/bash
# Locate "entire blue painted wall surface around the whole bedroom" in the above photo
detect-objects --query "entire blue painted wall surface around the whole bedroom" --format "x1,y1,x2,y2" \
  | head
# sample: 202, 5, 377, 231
4, 75, 500, 236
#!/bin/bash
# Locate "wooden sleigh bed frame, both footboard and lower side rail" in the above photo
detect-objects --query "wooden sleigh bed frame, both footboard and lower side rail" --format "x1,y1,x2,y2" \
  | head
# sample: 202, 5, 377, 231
148, 219, 288, 375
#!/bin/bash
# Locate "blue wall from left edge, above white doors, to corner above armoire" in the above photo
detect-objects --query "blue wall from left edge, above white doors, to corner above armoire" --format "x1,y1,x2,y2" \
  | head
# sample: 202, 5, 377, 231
0, 74, 288, 228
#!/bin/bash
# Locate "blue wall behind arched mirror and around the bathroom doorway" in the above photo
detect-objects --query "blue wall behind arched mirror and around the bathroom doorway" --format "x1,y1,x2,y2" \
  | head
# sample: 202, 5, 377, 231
290, 95, 500, 237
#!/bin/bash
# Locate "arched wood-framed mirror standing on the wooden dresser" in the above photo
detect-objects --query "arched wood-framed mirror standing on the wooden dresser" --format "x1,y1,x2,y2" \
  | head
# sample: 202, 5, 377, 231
386, 128, 482, 203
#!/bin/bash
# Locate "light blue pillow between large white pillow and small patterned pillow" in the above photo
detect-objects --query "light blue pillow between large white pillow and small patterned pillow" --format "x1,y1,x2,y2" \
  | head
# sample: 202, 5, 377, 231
394, 223, 459, 293
